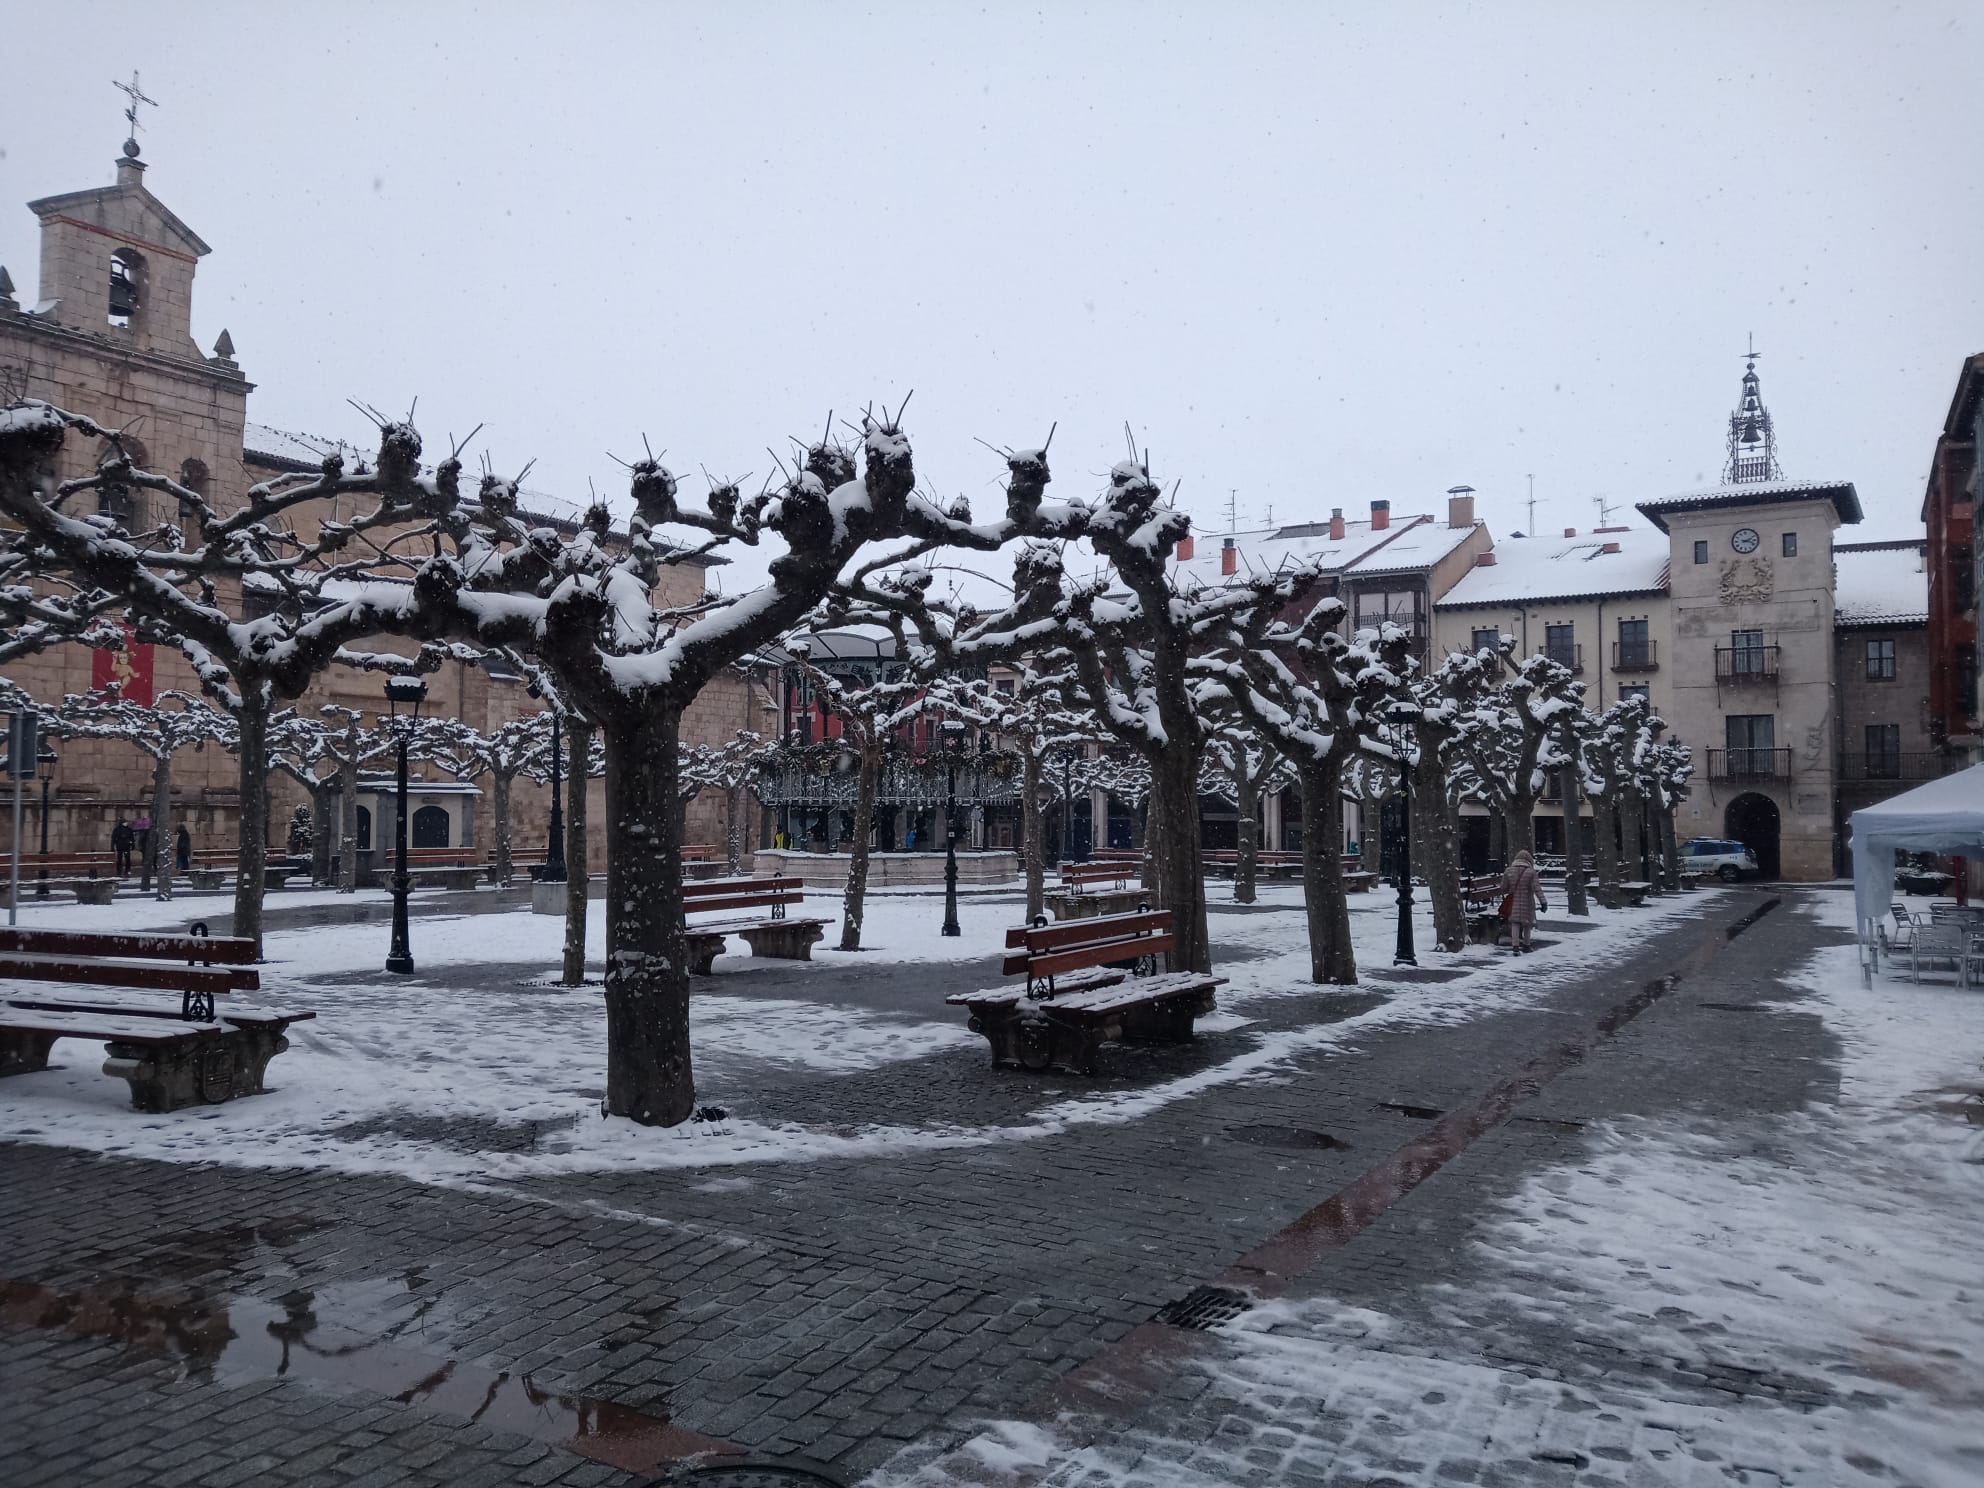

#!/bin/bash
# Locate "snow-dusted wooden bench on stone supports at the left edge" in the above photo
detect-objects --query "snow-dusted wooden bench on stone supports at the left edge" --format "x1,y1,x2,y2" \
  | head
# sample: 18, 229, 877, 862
0, 930, 315, 1111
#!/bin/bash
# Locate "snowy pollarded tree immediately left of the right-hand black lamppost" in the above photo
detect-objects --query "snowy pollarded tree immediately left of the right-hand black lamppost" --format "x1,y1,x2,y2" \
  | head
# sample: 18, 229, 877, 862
1190, 595, 1413, 982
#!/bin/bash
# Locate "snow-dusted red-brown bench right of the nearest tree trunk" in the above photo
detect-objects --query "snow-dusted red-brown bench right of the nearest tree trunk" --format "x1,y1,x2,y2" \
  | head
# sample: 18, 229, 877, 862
944, 909, 1226, 1075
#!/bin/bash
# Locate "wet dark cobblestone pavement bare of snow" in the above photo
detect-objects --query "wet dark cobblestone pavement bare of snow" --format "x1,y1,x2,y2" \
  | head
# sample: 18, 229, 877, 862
0, 891, 1857, 1488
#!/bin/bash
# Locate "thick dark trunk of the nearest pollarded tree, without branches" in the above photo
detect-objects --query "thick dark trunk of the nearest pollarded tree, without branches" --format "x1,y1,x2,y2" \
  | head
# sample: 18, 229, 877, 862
603, 696, 696, 1127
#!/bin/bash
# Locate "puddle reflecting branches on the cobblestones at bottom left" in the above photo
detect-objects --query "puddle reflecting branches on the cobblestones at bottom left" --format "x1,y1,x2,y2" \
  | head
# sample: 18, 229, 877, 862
0, 1272, 738, 1472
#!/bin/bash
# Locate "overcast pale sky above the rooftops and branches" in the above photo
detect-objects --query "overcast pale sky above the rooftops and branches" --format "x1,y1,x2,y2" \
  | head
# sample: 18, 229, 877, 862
0, 0, 1984, 575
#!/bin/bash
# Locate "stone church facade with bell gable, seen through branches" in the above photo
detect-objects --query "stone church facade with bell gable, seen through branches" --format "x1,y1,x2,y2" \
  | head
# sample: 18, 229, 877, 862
0, 147, 776, 871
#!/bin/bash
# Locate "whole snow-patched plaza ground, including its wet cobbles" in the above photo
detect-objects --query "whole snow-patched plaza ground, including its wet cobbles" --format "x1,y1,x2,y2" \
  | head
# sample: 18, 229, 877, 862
0, 885, 1984, 1488
